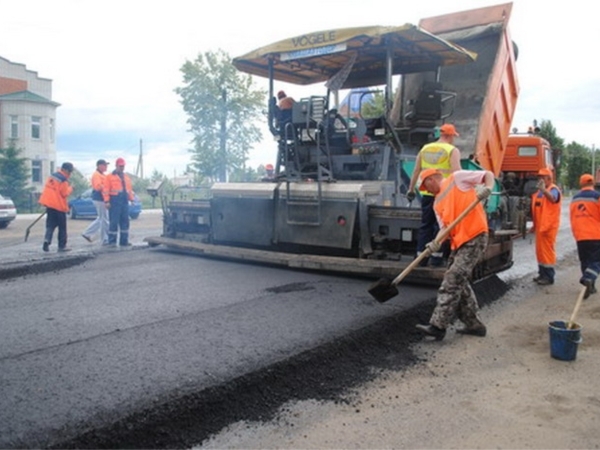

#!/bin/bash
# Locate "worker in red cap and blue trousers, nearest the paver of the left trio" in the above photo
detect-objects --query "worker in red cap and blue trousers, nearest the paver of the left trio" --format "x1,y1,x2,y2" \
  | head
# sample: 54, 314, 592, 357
102, 158, 133, 247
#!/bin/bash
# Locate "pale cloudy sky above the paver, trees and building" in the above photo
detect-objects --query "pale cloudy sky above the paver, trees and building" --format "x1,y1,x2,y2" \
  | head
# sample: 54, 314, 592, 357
0, 0, 600, 176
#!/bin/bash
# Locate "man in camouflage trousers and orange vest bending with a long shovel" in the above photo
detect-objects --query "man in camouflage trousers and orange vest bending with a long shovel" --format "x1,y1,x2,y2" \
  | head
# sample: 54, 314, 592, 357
416, 169, 495, 340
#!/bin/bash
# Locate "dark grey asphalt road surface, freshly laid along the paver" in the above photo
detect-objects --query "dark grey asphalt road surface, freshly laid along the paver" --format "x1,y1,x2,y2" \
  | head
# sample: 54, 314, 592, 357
0, 203, 574, 448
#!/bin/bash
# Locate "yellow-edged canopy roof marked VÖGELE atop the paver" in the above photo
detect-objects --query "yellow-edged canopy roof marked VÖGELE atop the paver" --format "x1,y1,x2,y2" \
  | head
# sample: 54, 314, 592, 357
233, 24, 477, 89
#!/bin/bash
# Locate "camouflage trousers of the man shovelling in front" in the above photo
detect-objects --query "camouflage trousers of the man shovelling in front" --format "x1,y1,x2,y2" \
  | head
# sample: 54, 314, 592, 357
429, 234, 488, 329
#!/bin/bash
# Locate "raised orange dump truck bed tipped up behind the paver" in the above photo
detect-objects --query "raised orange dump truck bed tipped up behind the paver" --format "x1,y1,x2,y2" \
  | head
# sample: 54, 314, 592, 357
404, 3, 519, 176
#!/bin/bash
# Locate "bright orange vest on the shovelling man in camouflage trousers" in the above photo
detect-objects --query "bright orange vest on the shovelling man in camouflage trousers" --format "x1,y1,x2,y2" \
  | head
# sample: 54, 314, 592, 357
433, 171, 489, 250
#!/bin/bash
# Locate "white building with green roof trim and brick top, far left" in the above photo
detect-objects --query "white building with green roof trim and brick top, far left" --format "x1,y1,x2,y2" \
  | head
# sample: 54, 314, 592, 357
0, 57, 60, 192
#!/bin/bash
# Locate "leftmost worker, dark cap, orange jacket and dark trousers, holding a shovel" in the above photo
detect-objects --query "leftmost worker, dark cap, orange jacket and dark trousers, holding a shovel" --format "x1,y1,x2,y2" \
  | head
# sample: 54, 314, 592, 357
39, 162, 73, 252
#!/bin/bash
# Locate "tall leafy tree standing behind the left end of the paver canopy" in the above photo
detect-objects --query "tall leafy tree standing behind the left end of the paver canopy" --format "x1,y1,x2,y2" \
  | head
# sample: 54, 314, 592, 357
175, 50, 266, 181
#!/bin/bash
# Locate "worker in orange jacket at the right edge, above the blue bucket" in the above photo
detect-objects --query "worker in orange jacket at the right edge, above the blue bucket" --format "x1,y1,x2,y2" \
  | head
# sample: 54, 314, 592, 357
569, 173, 600, 298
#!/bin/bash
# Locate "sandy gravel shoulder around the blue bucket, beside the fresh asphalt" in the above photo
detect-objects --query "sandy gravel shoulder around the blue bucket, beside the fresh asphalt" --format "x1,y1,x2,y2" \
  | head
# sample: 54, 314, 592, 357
198, 255, 600, 449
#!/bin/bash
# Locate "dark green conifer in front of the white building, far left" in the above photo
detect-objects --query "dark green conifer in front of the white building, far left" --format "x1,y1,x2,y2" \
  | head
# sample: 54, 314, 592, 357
0, 142, 33, 209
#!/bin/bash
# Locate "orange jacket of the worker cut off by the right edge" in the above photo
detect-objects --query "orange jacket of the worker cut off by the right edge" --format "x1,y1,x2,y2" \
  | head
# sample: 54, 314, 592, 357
569, 186, 600, 241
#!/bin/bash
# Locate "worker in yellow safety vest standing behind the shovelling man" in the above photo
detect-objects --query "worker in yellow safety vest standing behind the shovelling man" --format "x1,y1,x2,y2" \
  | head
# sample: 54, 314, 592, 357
406, 123, 460, 266
